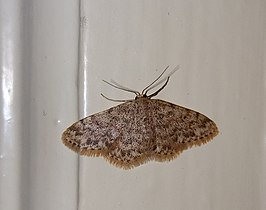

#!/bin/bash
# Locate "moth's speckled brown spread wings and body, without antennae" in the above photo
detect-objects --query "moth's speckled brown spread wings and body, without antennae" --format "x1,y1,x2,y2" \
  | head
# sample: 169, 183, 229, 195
62, 97, 218, 169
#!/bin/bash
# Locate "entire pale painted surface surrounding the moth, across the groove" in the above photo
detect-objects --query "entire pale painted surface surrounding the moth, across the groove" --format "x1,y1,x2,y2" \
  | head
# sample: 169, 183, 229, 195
0, 0, 266, 210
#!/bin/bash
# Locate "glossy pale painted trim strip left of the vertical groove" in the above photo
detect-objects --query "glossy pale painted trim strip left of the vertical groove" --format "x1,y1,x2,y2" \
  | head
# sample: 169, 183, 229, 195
0, 0, 79, 210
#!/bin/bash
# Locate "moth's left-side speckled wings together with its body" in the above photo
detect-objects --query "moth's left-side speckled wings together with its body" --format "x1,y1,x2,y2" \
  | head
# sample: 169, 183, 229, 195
62, 99, 152, 169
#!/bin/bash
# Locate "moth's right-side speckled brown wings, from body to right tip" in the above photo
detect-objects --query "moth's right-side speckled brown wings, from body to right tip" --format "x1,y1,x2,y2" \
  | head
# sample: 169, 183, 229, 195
152, 99, 218, 161
